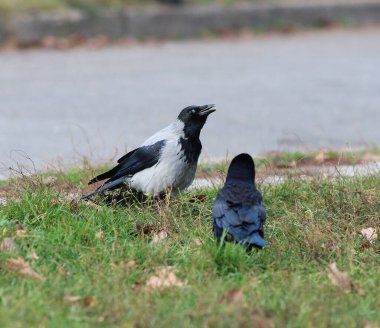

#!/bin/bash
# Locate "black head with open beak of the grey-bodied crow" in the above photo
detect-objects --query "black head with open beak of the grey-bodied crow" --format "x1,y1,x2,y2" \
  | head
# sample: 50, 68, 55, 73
178, 105, 215, 138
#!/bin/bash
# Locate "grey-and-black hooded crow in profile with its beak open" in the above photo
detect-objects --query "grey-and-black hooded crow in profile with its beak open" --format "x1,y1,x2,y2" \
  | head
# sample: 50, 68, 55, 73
82, 105, 215, 199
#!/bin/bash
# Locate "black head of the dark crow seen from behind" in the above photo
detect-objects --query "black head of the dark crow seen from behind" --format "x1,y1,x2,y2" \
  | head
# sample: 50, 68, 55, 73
226, 154, 255, 183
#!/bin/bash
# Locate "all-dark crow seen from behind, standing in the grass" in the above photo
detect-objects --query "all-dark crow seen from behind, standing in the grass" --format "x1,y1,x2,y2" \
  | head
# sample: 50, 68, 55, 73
212, 154, 268, 250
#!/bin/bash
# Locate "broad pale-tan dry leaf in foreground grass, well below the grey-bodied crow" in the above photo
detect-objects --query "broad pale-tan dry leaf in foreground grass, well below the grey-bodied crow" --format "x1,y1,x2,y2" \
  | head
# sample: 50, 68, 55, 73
145, 266, 186, 292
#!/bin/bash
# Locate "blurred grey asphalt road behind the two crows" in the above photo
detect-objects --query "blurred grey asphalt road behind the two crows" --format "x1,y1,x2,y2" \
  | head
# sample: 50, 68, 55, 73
0, 28, 380, 175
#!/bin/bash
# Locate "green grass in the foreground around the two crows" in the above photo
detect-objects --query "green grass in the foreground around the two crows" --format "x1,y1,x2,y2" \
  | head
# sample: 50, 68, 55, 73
0, 170, 380, 328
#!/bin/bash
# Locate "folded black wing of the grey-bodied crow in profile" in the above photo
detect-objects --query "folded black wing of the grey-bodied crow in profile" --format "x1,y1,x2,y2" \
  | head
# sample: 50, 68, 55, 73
88, 140, 166, 184
